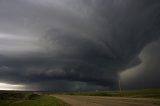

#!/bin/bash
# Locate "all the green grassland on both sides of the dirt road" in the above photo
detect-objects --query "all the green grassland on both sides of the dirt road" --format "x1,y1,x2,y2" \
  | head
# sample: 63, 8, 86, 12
0, 89, 160, 106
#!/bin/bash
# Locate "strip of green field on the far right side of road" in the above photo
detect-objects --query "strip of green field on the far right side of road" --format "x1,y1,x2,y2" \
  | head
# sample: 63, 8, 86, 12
63, 89, 160, 99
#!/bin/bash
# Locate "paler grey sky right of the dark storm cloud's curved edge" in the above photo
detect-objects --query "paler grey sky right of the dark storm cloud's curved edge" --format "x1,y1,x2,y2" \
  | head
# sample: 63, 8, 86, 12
121, 40, 160, 89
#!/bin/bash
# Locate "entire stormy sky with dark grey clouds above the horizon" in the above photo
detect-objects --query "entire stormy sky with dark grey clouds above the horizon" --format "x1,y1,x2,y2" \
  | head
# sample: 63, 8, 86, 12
0, 0, 160, 91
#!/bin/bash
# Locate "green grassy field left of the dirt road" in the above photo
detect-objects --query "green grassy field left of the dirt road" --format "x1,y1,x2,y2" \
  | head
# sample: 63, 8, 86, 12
0, 92, 69, 106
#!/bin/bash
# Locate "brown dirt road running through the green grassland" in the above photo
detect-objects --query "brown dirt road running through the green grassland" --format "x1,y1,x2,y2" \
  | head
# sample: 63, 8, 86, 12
55, 95, 160, 106
